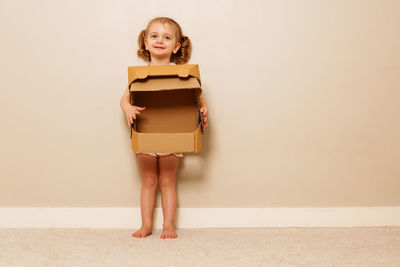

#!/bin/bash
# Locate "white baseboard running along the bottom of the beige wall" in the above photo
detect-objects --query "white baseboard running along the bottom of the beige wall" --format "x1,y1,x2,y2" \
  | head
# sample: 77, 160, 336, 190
0, 207, 400, 229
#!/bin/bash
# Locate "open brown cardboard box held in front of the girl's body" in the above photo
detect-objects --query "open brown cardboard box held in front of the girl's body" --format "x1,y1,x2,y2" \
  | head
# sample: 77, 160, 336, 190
128, 64, 203, 153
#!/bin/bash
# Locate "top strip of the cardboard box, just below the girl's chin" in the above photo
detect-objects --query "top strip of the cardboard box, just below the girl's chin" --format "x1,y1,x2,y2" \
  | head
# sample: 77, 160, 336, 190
128, 64, 201, 87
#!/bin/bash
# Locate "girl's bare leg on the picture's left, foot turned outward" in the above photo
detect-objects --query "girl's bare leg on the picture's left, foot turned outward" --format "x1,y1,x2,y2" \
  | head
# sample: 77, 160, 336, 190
132, 154, 158, 238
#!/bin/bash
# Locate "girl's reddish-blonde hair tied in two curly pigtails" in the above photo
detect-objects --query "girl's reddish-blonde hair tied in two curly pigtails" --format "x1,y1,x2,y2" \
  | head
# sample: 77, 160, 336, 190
137, 17, 192, 64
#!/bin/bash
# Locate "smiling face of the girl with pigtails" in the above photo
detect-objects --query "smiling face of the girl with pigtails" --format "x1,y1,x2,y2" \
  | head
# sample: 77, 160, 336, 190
144, 22, 181, 59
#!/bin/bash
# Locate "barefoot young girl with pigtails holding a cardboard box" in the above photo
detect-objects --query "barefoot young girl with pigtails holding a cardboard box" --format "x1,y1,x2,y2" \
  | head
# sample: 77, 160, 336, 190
121, 17, 208, 239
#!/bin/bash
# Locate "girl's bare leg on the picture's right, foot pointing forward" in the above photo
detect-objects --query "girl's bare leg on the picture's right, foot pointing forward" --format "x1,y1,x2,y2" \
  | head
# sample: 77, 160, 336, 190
159, 155, 179, 239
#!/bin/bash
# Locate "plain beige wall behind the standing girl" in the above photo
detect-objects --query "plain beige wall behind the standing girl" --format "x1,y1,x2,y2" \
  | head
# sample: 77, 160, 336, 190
0, 0, 400, 207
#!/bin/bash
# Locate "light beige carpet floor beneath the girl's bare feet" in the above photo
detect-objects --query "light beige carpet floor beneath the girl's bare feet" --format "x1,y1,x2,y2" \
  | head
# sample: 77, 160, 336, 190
0, 227, 400, 267
